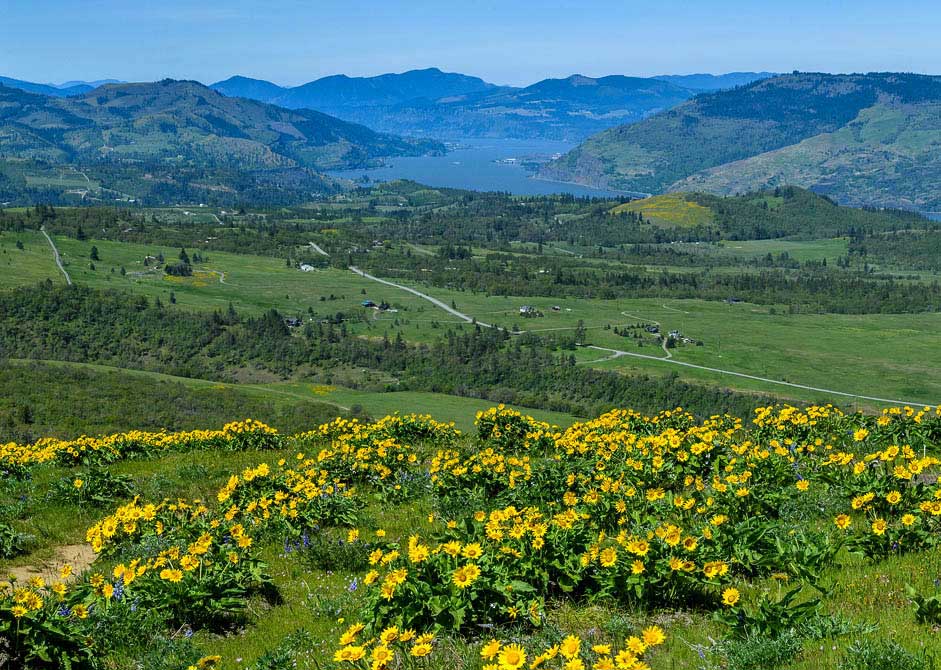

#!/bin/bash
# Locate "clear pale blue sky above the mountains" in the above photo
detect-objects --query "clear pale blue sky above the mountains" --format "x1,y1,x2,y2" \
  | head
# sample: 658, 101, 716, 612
0, 0, 941, 85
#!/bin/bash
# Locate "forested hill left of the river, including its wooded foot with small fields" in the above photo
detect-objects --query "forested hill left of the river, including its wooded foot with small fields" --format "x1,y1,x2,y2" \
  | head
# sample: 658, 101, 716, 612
0, 79, 444, 202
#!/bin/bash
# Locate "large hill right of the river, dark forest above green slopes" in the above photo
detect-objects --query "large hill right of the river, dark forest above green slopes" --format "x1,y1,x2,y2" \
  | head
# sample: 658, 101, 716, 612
541, 73, 941, 209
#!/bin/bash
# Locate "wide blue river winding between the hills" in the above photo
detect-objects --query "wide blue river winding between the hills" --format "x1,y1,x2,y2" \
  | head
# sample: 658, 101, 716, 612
330, 139, 636, 198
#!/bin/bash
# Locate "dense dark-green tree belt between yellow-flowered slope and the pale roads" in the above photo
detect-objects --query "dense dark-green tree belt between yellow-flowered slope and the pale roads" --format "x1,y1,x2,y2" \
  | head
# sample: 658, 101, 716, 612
0, 281, 770, 416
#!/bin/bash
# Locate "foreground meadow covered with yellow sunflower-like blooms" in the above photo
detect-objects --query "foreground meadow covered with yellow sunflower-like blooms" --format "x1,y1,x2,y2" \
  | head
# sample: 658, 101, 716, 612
0, 408, 941, 670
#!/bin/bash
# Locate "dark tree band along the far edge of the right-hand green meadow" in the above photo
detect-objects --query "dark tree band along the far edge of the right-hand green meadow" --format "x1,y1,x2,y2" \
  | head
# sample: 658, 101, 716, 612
354, 253, 941, 314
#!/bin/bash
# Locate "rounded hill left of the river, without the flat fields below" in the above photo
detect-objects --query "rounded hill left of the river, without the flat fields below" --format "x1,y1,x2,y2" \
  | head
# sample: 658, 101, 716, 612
0, 80, 438, 170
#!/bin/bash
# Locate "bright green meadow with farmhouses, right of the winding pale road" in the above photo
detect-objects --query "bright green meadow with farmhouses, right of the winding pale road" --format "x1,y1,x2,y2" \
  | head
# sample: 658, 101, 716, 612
352, 282, 941, 407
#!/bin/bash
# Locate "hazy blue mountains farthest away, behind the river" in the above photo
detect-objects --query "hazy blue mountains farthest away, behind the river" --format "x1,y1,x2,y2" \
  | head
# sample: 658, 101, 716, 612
212, 68, 695, 141
